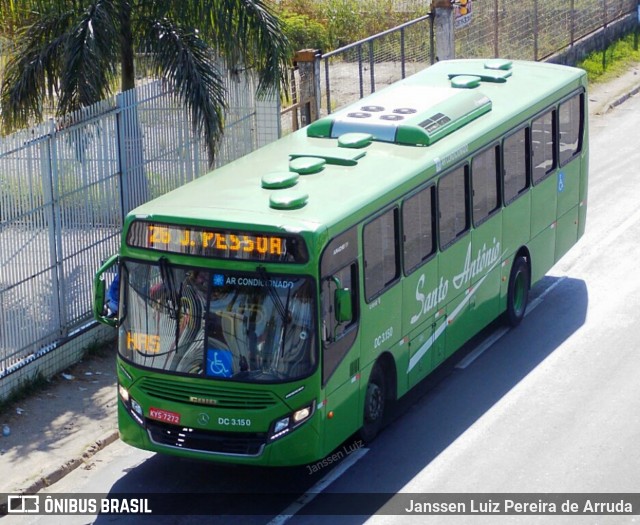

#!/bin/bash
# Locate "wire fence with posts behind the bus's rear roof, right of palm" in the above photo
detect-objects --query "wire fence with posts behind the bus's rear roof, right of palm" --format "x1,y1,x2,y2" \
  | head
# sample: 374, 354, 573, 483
308, 0, 638, 118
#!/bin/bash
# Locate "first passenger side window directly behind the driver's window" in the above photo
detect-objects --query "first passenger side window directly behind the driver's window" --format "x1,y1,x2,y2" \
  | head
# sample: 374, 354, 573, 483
363, 208, 400, 301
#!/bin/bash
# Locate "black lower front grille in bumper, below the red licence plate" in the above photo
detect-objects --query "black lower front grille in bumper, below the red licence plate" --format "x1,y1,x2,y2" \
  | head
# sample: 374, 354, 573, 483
145, 419, 267, 456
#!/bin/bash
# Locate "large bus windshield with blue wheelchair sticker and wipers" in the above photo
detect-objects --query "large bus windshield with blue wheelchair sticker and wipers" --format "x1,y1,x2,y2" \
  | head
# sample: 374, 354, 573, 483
119, 259, 317, 382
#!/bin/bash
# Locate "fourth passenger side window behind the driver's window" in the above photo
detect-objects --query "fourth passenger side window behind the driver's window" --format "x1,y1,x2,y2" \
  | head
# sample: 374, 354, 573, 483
471, 146, 500, 226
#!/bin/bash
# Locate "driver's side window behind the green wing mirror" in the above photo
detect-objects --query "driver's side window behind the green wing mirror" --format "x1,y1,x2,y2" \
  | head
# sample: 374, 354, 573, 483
322, 263, 358, 344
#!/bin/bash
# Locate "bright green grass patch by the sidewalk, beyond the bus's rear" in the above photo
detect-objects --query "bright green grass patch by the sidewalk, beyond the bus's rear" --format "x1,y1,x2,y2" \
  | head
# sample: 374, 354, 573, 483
577, 33, 640, 82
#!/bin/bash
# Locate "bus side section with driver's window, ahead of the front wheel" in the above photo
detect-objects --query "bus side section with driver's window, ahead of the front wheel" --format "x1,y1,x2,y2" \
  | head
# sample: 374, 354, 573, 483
320, 227, 360, 452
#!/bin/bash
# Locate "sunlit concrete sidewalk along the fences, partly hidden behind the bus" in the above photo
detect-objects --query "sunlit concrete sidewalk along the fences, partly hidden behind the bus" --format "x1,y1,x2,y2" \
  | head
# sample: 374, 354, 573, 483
0, 64, 640, 508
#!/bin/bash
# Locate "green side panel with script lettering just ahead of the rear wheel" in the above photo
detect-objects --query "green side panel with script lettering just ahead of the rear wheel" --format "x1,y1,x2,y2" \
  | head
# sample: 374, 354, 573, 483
467, 213, 504, 332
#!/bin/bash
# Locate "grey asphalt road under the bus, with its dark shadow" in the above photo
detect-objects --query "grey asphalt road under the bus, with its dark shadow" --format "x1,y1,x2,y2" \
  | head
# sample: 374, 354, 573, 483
7, 89, 640, 525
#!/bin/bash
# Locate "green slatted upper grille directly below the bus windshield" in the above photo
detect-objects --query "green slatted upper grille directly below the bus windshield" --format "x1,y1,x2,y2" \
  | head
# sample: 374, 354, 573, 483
138, 377, 278, 410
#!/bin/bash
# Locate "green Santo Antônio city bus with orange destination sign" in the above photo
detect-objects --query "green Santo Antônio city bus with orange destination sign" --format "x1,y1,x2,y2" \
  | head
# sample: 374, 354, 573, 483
94, 59, 588, 466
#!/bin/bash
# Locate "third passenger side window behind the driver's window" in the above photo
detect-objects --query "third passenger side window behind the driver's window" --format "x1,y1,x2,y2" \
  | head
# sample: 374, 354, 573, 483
438, 164, 469, 249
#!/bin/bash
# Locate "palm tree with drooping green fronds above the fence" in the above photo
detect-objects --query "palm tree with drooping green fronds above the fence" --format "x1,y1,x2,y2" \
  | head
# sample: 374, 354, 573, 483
0, 0, 290, 164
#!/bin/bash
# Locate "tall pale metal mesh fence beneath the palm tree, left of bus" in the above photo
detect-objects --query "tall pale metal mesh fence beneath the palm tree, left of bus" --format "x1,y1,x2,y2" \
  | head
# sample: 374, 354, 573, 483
0, 72, 278, 392
